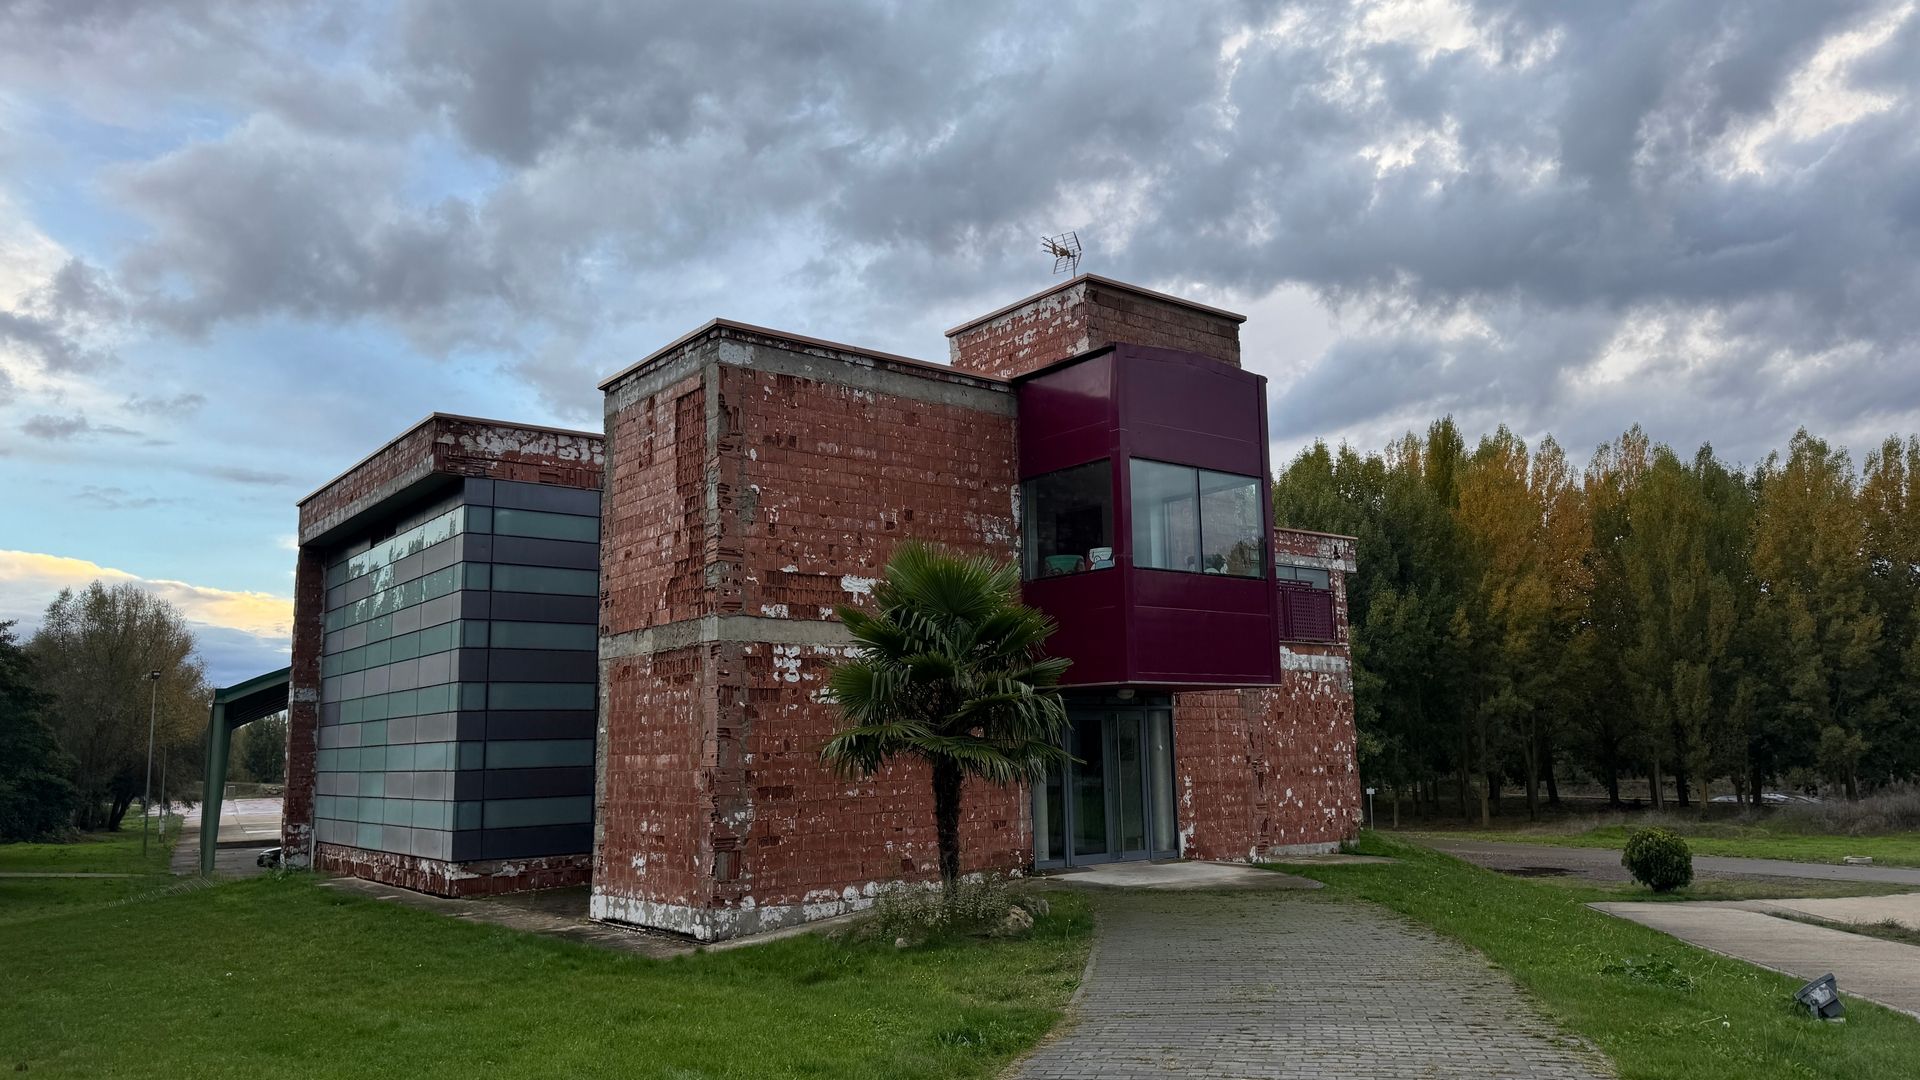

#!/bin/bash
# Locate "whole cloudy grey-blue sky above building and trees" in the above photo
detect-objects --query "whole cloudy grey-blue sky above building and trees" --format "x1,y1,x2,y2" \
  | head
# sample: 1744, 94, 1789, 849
0, 0, 1920, 680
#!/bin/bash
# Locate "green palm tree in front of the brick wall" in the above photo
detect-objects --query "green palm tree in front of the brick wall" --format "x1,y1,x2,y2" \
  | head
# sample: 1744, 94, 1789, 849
820, 542, 1068, 892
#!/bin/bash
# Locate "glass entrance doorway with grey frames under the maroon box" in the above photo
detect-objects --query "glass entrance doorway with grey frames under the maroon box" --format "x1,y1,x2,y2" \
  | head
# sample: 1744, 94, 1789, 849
1033, 694, 1179, 867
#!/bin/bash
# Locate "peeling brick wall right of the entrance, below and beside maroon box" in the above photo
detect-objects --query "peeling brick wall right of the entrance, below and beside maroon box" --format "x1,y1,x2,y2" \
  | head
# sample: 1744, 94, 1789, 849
1173, 528, 1361, 859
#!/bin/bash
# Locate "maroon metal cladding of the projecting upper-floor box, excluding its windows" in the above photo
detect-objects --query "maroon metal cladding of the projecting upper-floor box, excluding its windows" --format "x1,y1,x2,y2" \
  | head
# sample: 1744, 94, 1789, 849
1016, 344, 1281, 686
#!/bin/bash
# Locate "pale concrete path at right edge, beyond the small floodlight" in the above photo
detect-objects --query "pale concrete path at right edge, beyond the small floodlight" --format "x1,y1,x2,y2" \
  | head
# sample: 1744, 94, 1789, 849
1592, 899, 1920, 1019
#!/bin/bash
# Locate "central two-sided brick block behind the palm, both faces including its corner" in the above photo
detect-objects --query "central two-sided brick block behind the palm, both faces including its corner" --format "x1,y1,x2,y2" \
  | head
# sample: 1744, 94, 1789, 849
593, 325, 1031, 938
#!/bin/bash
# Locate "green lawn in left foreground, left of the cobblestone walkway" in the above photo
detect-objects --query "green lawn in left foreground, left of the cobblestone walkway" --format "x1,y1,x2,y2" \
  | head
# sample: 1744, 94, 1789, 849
0, 874, 1092, 1080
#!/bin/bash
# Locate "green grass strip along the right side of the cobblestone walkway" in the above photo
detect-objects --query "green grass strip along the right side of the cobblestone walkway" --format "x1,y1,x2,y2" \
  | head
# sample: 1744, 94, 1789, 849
1283, 834, 1920, 1080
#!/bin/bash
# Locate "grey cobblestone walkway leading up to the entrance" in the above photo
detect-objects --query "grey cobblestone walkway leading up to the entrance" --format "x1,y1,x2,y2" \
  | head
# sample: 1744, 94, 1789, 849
1012, 892, 1611, 1080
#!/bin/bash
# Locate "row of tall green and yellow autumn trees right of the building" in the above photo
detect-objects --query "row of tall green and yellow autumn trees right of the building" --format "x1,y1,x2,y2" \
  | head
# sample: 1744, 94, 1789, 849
1275, 419, 1920, 821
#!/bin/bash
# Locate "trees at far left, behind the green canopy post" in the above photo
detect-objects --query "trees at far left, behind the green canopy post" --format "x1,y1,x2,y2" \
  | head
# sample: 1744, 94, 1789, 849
0, 582, 286, 840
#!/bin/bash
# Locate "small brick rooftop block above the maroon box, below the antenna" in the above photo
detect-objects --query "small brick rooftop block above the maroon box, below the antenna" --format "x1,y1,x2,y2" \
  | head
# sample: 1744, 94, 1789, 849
947, 275, 1242, 379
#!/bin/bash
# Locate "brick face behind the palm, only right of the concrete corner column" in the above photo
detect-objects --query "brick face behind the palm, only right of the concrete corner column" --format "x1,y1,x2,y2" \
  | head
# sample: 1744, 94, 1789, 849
716, 363, 1031, 907
